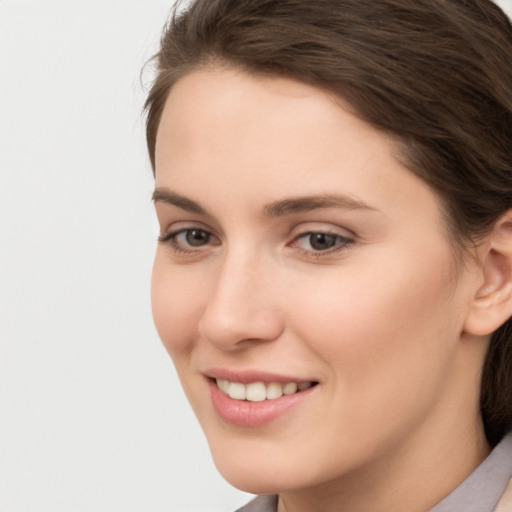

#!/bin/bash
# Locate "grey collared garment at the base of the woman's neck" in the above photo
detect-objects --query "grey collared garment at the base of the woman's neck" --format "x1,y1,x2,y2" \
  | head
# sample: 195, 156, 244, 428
236, 434, 512, 512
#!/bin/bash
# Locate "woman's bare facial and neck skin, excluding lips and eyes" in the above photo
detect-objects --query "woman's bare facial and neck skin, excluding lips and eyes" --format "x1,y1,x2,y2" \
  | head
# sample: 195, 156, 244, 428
152, 68, 489, 512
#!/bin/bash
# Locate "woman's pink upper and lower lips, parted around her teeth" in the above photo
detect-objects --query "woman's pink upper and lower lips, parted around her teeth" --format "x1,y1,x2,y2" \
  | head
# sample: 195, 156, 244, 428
205, 370, 317, 428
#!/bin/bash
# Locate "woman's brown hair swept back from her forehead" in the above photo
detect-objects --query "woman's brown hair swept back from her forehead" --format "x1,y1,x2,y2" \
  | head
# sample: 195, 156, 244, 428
145, 0, 512, 445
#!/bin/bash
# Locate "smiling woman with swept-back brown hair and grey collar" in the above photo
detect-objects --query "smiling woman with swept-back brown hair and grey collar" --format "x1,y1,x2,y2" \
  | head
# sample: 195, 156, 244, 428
146, 0, 512, 512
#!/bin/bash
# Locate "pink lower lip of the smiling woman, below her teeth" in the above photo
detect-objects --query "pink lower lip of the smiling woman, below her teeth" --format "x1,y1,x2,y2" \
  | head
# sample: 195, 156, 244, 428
208, 379, 316, 428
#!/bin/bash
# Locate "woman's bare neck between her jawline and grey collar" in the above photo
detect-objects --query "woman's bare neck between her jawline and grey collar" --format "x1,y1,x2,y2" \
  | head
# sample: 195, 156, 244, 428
278, 336, 491, 512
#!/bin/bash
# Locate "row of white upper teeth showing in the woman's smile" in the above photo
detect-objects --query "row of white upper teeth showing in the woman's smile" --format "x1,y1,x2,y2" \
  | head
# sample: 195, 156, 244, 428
217, 379, 313, 402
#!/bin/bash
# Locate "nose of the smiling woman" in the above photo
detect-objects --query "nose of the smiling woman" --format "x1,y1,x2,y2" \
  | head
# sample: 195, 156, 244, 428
199, 251, 283, 350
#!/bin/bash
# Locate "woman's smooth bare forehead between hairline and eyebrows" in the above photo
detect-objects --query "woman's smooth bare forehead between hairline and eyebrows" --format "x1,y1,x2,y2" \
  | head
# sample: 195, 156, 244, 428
156, 69, 448, 230
